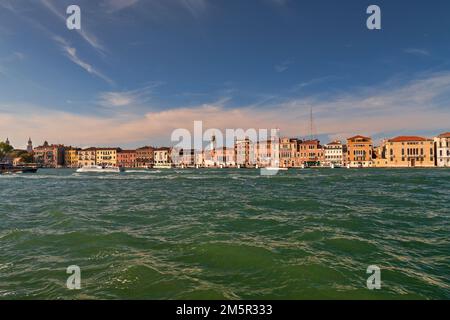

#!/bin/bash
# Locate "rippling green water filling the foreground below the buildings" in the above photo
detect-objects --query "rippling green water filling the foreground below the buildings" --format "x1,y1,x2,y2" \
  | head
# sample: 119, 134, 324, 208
0, 169, 450, 299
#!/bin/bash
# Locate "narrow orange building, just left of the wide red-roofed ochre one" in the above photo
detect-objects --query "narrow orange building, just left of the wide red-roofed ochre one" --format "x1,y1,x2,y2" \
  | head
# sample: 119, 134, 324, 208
347, 135, 373, 168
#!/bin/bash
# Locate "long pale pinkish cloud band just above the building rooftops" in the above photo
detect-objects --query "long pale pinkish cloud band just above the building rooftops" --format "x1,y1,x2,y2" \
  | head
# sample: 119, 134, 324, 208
0, 72, 450, 145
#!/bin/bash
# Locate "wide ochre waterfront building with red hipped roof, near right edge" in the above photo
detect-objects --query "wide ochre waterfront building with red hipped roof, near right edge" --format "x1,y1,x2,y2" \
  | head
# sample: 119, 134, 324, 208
385, 136, 435, 167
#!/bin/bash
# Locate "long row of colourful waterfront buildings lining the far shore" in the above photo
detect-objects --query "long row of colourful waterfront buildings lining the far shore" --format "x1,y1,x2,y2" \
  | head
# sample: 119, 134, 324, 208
6, 132, 450, 168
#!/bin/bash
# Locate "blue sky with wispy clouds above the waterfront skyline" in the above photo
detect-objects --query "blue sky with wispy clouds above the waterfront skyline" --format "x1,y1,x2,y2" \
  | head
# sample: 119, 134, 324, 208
0, 0, 450, 147
